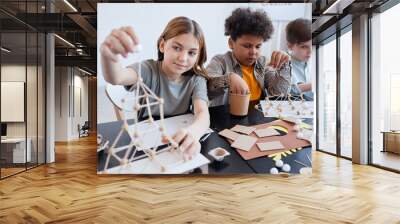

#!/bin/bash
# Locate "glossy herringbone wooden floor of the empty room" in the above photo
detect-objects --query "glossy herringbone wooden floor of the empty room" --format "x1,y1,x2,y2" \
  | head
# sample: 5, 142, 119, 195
0, 137, 400, 224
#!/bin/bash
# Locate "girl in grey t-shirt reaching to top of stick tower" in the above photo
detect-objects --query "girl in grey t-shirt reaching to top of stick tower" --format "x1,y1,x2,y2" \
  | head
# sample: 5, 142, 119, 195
100, 17, 210, 159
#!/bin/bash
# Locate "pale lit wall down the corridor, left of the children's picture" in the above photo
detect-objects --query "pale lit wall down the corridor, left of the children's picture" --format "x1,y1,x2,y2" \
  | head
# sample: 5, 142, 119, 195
55, 67, 88, 141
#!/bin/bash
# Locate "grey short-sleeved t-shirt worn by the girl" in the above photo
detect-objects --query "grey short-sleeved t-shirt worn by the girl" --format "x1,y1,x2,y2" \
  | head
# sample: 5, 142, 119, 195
125, 59, 208, 117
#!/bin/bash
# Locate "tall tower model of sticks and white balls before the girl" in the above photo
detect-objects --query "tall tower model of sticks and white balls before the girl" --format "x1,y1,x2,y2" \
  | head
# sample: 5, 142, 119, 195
98, 57, 185, 174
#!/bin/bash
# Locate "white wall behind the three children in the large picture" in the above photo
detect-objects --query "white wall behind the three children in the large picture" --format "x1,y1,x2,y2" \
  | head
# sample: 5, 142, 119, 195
97, 3, 311, 123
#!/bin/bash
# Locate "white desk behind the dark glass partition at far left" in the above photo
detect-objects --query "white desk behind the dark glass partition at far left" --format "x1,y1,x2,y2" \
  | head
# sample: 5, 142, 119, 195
1, 138, 32, 163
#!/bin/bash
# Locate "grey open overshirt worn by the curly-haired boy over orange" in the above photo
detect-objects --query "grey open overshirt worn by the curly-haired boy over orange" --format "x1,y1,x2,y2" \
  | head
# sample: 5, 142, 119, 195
207, 51, 291, 106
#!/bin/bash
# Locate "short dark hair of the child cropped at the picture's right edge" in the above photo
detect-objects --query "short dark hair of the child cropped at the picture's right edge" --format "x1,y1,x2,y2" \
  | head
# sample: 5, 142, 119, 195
286, 18, 312, 44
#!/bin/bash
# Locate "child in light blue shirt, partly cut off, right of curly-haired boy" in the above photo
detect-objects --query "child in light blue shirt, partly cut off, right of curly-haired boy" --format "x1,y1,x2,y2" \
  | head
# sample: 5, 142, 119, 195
286, 18, 314, 101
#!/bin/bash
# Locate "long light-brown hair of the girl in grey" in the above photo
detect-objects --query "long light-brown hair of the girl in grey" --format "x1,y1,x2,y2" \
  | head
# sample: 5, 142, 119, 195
157, 16, 209, 79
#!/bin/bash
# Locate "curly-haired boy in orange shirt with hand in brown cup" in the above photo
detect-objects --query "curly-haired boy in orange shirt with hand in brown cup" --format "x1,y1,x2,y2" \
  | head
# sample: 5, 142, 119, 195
207, 8, 291, 106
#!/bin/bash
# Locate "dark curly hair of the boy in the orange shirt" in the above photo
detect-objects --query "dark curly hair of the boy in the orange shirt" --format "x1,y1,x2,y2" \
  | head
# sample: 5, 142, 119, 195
225, 8, 274, 41
